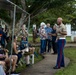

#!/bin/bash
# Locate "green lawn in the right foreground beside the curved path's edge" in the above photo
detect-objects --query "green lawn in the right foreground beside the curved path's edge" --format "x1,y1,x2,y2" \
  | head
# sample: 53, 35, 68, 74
55, 48, 76, 75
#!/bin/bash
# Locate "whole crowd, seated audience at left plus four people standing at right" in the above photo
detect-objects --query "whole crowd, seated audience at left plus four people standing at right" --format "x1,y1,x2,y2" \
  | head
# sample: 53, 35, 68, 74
0, 17, 67, 75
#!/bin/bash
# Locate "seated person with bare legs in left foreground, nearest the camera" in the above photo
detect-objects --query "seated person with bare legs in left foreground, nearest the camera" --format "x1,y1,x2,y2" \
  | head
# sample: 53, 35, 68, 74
0, 44, 14, 73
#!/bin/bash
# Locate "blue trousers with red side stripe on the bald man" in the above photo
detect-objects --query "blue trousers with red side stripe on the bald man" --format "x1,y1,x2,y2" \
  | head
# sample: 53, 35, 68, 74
56, 39, 66, 67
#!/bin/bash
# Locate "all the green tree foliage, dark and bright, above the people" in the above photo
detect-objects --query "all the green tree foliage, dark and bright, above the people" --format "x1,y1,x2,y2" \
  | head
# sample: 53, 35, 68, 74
0, 0, 76, 25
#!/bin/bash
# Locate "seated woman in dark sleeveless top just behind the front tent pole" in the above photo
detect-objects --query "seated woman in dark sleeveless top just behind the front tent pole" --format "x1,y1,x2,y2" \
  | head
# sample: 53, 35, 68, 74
6, 36, 22, 65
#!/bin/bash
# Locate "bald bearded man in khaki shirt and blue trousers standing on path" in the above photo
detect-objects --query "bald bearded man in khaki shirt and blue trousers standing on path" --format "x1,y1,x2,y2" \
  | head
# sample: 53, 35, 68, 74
53, 17, 67, 69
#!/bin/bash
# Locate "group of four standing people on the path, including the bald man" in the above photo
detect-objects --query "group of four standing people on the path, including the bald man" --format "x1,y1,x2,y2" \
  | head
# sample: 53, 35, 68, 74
39, 17, 67, 69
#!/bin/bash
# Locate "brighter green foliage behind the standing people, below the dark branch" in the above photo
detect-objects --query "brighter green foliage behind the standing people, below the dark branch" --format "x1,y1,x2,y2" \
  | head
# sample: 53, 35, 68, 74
30, 0, 75, 25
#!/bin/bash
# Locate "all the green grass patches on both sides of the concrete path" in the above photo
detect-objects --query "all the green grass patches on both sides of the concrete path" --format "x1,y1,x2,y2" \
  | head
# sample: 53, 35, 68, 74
16, 37, 72, 75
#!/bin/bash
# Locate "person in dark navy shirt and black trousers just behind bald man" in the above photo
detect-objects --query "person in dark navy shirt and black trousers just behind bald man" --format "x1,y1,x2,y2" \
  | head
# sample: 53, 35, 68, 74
52, 25, 57, 54
